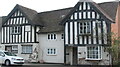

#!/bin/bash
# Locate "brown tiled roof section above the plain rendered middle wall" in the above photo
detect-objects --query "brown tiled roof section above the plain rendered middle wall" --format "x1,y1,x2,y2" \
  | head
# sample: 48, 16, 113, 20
38, 8, 72, 33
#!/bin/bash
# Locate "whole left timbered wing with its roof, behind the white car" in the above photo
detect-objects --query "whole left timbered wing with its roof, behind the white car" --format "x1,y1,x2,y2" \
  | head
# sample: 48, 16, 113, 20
2, 5, 42, 60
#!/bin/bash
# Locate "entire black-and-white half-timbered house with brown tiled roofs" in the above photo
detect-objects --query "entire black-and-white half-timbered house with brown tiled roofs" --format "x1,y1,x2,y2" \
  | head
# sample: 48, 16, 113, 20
0, 0, 117, 65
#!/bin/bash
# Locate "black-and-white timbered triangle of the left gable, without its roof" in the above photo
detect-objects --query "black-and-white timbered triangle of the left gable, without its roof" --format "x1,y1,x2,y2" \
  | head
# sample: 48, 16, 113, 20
3, 9, 29, 25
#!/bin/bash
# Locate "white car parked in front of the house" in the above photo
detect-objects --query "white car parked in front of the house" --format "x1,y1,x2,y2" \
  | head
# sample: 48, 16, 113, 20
0, 50, 24, 66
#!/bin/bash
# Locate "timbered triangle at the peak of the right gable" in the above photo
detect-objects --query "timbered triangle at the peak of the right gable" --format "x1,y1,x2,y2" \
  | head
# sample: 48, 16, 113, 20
70, 2, 100, 20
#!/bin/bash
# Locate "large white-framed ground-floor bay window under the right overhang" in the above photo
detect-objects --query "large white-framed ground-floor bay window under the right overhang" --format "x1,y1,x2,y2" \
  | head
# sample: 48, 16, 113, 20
86, 46, 102, 60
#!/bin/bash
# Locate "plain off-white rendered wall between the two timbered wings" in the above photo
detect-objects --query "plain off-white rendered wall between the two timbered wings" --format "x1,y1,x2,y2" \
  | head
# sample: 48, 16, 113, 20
39, 33, 64, 63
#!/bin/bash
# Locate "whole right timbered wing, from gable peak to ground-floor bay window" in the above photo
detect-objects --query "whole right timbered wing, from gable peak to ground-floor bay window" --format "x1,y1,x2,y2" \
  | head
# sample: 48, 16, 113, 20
61, 0, 114, 65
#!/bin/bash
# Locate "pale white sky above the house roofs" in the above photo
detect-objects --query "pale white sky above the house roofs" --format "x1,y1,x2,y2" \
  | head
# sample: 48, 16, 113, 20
0, 0, 116, 16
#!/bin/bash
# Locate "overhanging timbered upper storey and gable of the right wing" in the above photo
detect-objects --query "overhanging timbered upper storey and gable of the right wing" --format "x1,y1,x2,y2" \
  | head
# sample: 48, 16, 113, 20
62, 2, 112, 46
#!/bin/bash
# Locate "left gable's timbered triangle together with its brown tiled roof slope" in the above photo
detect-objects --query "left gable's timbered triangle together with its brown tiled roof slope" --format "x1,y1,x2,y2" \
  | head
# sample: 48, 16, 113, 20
3, 4, 43, 26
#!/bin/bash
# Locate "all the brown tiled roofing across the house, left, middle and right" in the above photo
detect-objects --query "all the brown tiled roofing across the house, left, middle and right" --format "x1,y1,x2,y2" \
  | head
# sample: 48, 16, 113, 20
4, 0, 118, 33
